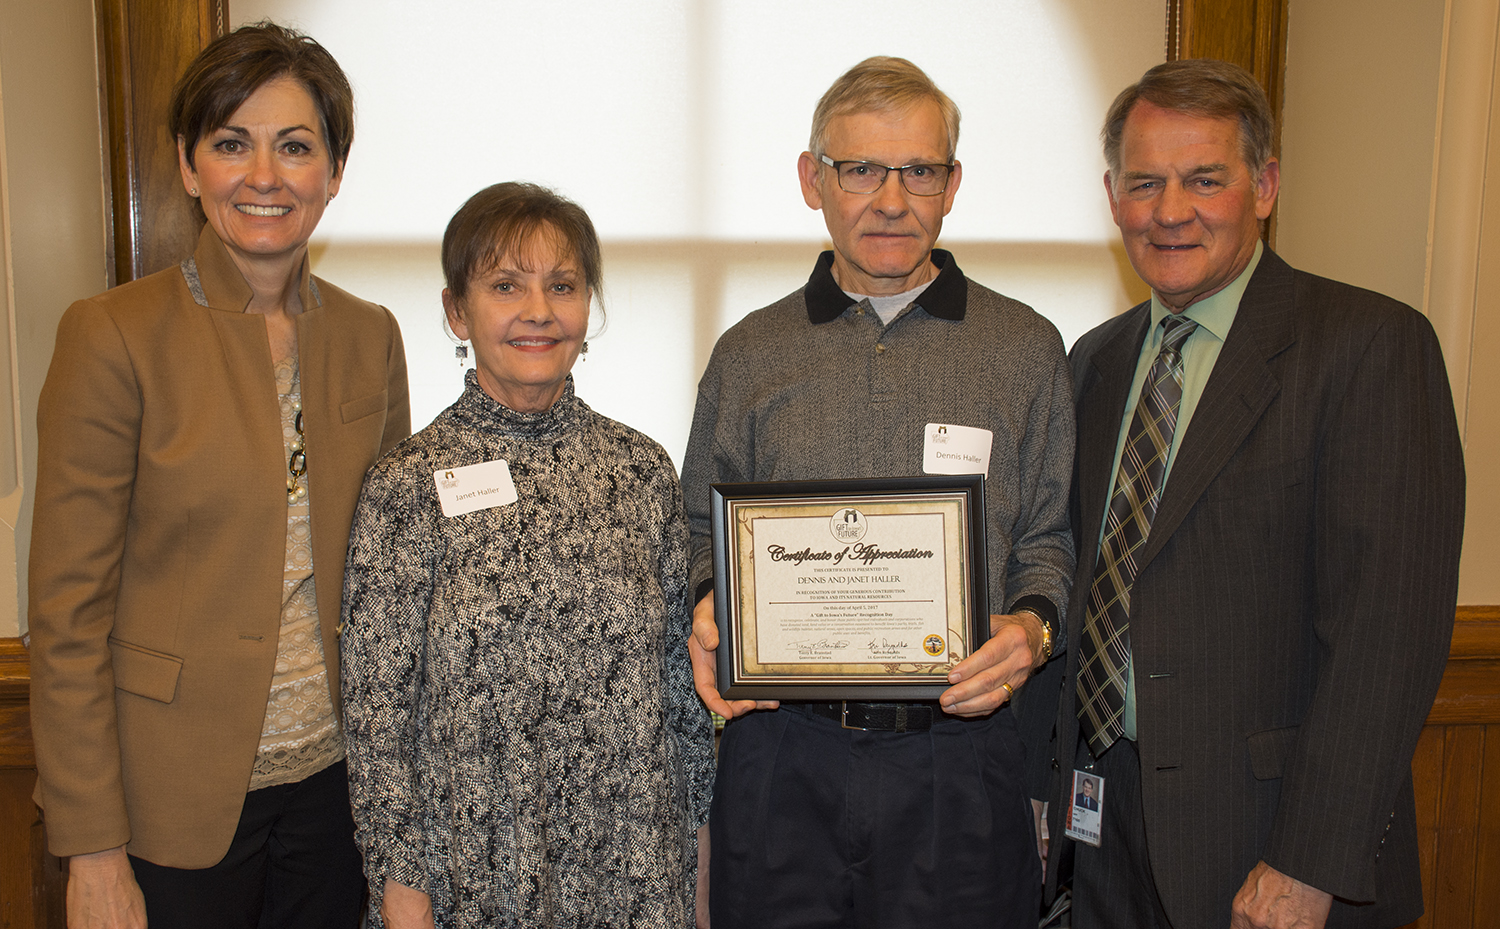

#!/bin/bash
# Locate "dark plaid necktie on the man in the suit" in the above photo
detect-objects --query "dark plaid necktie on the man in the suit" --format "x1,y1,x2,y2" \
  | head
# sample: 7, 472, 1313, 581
1079, 315, 1199, 758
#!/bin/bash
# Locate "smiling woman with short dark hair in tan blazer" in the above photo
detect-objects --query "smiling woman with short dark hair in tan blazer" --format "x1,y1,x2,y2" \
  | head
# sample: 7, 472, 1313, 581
30, 23, 410, 929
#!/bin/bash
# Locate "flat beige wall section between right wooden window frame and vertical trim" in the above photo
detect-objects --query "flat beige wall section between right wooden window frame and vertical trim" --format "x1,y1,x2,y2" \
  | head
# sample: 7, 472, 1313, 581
1277, 0, 1443, 306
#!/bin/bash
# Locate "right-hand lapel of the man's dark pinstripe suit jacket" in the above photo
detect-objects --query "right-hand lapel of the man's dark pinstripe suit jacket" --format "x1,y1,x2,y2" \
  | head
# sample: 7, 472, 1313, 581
1140, 249, 1296, 570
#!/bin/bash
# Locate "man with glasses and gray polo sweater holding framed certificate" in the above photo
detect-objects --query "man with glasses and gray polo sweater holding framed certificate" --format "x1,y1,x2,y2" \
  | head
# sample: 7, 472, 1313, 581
683, 59, 1074, 929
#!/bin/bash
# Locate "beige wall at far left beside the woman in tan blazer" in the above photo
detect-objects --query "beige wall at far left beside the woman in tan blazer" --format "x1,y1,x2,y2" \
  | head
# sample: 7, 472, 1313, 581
0, 0, 108, 638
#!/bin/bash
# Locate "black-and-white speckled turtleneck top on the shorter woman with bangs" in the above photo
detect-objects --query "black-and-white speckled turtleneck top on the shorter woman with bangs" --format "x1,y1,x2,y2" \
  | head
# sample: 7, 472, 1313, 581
341, 372, 713, 929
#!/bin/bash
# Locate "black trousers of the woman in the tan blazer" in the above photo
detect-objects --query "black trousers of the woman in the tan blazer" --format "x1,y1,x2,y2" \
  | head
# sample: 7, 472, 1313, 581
131, 761, 365, 929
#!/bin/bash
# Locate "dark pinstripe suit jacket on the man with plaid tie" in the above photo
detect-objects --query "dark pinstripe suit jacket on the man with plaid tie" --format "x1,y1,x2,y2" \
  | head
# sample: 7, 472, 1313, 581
1049, 251, 1464, 927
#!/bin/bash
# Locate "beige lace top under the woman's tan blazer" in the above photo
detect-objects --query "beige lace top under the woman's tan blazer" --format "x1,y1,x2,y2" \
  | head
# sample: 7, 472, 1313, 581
251, 356, 344, 791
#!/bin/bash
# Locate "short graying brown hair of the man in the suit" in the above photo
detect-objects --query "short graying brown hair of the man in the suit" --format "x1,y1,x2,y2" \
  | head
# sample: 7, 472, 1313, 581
1100, 59, 1274, 182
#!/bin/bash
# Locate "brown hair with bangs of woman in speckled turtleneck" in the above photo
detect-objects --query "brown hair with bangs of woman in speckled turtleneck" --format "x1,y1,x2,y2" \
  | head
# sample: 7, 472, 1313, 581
443, 180, 605, 316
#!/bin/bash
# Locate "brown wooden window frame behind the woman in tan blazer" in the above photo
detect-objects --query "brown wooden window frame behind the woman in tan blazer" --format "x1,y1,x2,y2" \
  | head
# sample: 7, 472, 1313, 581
96, 0, 230, 284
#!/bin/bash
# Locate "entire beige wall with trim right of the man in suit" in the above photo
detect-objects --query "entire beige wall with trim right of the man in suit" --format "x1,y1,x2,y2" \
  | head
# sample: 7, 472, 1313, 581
1277, 0, 1500, 603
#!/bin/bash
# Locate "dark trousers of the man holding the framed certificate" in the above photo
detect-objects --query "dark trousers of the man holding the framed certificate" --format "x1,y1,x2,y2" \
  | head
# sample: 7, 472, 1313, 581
710, 704, 1041, 929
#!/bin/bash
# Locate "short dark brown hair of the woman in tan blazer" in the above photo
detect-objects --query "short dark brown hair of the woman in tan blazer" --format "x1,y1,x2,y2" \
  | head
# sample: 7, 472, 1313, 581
167, 20, 354, 174
